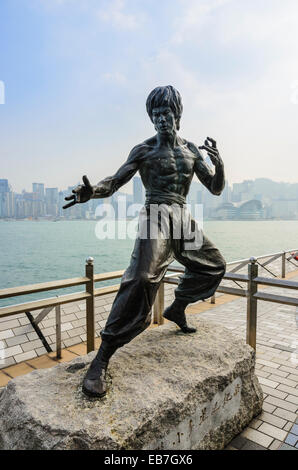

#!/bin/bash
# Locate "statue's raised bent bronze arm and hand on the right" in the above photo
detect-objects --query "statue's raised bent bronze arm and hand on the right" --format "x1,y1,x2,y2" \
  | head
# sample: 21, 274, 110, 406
189, 137, 225, 196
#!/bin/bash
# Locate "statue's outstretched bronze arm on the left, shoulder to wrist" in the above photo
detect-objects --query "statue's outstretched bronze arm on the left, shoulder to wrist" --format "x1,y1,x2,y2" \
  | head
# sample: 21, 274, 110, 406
92, 144, 147, 198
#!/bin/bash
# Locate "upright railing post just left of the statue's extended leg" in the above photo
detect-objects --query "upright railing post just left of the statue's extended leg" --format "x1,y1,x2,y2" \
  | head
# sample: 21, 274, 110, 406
86, 257, 95, 353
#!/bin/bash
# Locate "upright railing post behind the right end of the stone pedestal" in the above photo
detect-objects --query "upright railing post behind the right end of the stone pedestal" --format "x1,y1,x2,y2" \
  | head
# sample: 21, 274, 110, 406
246, 258, 258, 350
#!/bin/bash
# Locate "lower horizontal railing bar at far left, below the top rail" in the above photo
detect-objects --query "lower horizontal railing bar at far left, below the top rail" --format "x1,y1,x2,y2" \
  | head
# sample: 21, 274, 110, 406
0, 292, 91, 318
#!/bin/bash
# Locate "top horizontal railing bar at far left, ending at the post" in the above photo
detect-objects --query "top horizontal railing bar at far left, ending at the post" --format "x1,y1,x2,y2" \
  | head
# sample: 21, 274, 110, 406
0, 277, 90, 299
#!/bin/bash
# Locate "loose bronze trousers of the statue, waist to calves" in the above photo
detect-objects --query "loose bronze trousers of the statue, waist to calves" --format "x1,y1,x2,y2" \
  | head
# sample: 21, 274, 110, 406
101, 205, 226, 347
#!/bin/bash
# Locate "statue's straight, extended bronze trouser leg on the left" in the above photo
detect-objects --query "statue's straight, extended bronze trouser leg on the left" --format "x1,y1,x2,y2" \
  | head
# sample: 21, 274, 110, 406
87, 229, 174, 379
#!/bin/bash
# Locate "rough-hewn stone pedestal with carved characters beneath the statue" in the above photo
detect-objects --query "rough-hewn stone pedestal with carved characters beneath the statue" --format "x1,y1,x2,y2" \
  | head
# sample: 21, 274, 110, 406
0, 315, 263, 450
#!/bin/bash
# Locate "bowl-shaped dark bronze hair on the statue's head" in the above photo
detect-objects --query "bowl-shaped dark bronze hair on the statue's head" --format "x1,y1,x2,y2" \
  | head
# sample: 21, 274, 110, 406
146, 85, 183, 129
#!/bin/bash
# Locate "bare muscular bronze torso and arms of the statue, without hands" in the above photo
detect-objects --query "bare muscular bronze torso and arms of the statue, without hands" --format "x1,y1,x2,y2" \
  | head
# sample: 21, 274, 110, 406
92, 136, 224, 202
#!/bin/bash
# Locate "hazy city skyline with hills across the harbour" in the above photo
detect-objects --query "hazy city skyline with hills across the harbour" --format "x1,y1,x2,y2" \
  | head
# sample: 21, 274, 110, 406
0, 176, 298, 220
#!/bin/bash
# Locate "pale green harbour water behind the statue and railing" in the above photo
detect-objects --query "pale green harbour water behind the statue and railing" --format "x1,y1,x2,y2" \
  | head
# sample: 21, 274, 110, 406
0, 220, 298, 306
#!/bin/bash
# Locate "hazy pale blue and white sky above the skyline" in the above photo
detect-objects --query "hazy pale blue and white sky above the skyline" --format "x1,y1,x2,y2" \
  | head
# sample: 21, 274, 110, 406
0, 0, 298, 191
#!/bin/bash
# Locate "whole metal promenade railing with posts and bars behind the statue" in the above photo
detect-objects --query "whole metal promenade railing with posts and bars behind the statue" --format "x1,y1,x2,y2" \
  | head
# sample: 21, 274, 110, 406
0, 250, 298, 358
